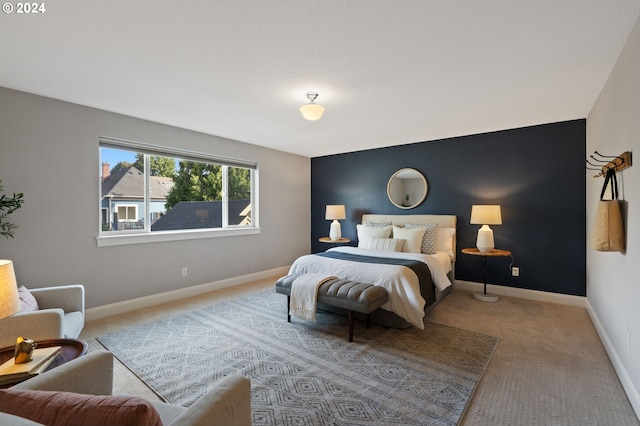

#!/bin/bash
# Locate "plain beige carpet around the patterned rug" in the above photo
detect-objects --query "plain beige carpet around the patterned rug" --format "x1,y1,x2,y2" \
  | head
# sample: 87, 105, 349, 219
81, 277, 640, 426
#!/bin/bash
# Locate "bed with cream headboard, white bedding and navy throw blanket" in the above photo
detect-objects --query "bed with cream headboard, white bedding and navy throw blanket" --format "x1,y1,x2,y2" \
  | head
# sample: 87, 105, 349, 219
289, 214, 457, 329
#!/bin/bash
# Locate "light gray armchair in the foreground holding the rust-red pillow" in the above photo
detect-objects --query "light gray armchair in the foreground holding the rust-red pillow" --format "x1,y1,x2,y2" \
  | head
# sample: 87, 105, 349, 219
0, 350, 251, 426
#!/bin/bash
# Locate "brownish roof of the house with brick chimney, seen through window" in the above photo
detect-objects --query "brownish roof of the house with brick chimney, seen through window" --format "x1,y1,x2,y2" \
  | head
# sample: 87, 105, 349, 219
102, 166, 174, 199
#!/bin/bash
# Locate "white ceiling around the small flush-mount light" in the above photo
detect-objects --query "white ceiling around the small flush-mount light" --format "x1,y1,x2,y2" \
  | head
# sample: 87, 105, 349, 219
0, 0, 640, 157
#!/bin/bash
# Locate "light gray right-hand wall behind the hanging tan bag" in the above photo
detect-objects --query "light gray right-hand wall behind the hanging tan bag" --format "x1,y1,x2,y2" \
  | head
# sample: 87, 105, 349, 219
587, 12, 640, 415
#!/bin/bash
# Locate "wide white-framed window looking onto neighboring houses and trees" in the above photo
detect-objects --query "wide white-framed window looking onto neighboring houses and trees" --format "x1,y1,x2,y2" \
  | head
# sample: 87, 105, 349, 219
98, 138, 257, 245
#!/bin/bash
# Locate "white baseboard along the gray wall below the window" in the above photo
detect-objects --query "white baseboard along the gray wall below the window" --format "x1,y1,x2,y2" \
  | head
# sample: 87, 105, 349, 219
85, 266, 289, 321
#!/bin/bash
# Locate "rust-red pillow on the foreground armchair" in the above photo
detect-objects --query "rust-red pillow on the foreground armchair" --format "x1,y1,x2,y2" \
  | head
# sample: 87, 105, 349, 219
0, 389, 162, 426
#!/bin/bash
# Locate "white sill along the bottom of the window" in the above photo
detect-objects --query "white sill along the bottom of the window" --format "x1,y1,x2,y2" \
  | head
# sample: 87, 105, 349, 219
96, 227, 260, 247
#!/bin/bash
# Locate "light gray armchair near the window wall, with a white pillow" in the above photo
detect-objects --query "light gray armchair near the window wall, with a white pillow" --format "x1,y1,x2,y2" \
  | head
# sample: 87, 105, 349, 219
0, 284, 85, 348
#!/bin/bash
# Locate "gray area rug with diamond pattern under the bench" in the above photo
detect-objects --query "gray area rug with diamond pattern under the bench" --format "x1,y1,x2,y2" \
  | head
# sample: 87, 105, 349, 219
98, 290, 498, 425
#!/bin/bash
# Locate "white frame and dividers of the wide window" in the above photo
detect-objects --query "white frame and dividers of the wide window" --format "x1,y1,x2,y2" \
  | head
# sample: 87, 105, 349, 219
96, 136, 260, 247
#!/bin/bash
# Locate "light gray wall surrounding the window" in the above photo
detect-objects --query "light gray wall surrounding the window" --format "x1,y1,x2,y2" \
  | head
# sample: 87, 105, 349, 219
0, 88, 310, 307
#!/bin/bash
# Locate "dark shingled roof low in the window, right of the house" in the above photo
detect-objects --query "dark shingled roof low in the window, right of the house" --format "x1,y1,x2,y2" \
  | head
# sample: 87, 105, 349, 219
151, 200, 251, 231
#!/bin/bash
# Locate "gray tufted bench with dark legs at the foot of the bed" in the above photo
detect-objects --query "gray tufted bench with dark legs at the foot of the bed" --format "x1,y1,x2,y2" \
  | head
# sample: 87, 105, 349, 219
276, 275, 389, 342
